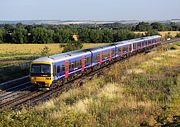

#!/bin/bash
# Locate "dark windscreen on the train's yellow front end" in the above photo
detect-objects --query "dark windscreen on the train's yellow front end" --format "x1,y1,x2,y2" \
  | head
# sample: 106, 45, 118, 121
31, 64, 51, 74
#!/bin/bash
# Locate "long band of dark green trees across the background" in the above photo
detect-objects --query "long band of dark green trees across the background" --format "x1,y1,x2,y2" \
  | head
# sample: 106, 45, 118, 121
0, 22, 180, 44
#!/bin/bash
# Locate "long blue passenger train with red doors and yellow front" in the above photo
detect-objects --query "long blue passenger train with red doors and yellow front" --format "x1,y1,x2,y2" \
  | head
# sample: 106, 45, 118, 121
30, 35, 161, 90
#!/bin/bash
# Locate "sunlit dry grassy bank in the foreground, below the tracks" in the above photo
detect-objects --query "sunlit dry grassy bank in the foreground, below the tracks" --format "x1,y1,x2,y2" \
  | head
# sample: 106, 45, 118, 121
0, 43, 180, 127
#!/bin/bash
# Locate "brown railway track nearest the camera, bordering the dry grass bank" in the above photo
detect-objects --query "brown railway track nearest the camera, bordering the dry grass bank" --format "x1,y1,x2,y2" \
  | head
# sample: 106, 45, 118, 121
0, 61, 107, 112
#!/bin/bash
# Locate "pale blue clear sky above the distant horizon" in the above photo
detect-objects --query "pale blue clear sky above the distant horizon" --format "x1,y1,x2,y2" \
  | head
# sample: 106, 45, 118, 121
0, 0, 180, 21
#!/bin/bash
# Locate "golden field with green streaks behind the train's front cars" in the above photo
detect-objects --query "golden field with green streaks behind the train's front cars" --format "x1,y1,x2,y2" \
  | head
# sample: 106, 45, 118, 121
0, 43, 105, 67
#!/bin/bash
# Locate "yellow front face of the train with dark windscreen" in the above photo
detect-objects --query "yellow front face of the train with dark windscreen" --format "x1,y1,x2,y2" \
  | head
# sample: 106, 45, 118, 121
30, 62, 53, 90
